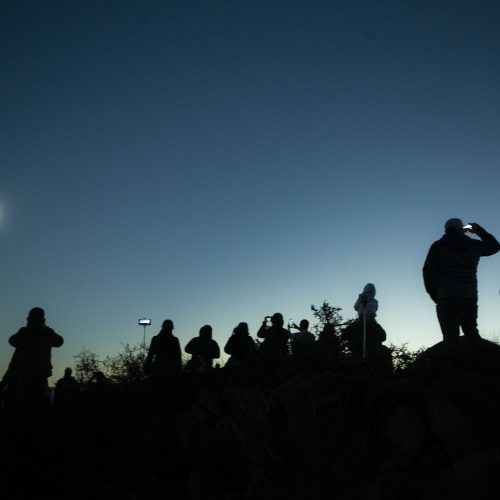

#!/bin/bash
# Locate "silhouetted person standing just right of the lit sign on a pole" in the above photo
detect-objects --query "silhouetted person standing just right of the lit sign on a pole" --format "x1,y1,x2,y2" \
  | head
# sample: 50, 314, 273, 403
144, 319, 182, 381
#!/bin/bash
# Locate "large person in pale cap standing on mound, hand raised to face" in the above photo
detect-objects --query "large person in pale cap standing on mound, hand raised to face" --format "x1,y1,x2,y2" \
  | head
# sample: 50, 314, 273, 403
423, 218, 500, 343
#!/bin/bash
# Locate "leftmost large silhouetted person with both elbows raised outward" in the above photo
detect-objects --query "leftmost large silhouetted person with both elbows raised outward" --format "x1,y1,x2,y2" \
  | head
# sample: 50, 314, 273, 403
9, 307, 64, 409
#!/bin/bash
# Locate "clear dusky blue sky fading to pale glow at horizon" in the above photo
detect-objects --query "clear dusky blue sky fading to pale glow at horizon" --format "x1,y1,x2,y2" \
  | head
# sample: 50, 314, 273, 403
0, 0, 500, 379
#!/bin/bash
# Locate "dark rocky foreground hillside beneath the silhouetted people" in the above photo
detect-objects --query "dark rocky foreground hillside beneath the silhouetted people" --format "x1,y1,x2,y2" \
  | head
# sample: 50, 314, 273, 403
0, 341, 500, 500
